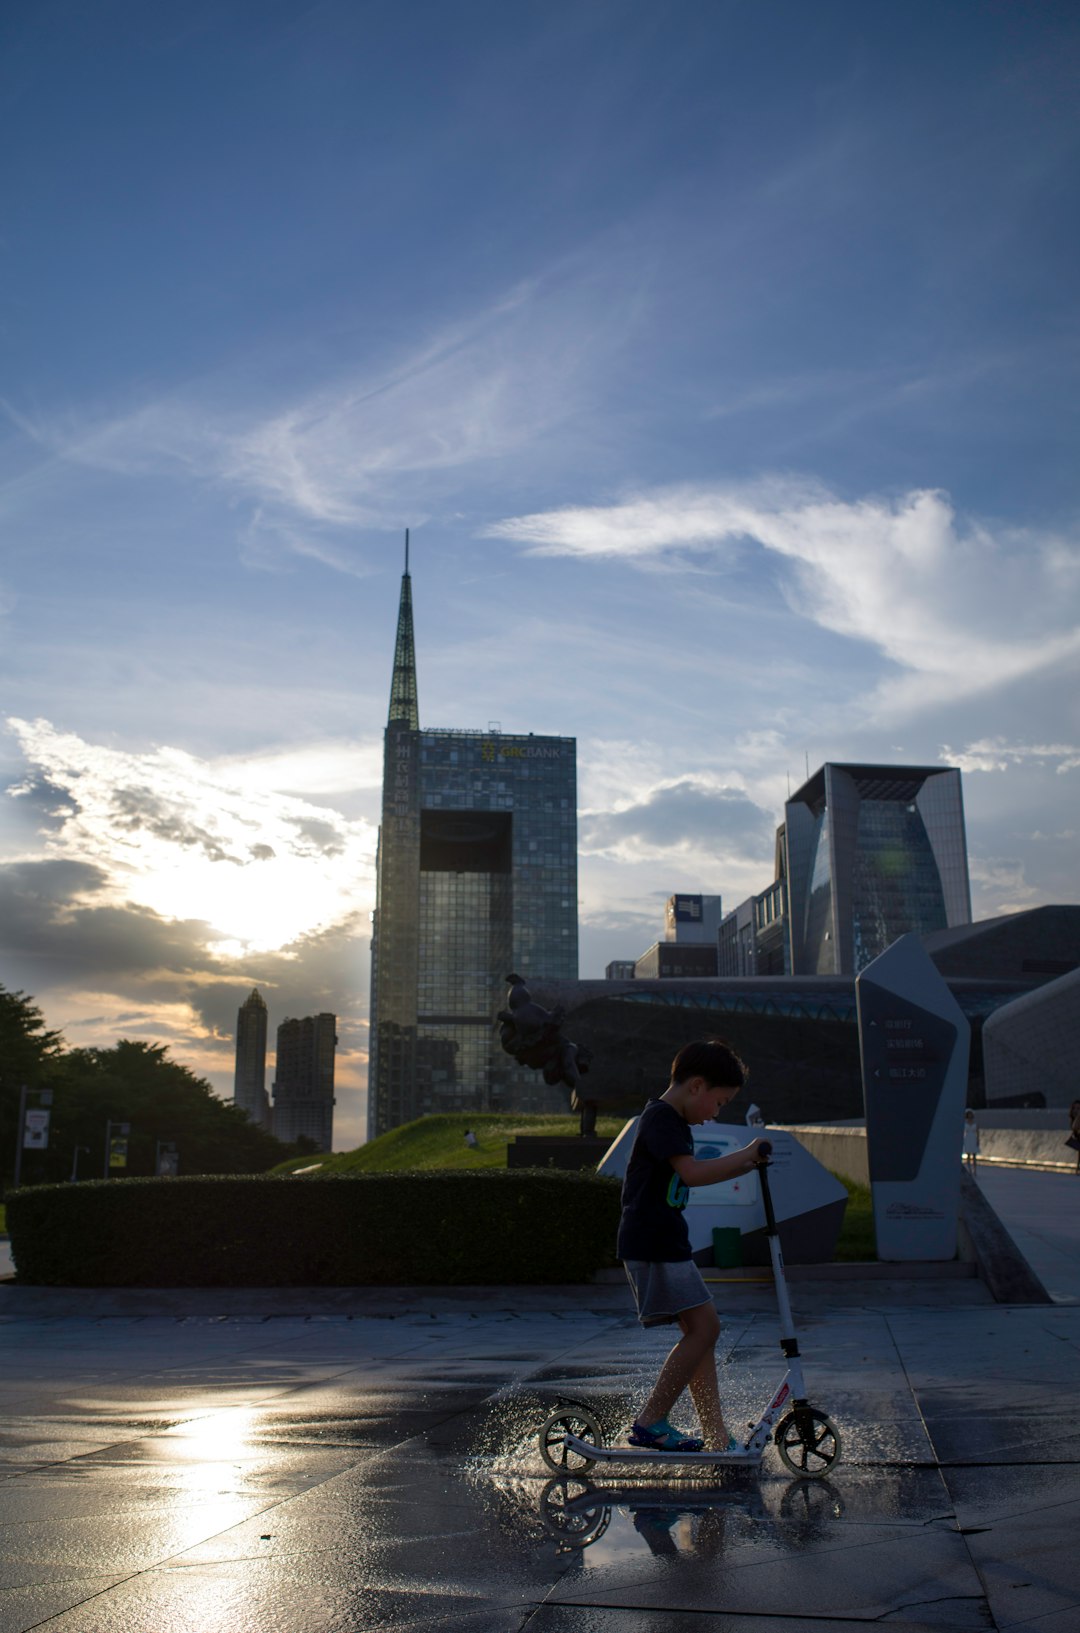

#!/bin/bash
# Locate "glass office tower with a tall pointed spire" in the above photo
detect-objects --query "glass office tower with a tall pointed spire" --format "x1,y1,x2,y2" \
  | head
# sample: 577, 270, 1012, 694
368, 536, 577, 1138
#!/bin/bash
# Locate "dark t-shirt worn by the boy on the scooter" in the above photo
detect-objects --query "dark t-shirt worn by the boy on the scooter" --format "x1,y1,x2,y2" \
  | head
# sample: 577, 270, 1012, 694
616, 1101, 694, 1264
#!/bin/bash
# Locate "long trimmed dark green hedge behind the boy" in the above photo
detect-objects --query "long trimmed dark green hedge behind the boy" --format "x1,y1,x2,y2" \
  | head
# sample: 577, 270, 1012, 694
8, 1169, 619, 1287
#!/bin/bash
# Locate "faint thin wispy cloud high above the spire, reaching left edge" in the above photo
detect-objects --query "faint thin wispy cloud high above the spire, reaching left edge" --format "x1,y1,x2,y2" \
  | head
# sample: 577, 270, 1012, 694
0, 250, 637, 548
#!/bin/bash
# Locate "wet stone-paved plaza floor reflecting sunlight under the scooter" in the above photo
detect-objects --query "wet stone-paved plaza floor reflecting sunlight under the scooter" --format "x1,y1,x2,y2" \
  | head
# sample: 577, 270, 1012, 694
0, 1282, 1080, 1633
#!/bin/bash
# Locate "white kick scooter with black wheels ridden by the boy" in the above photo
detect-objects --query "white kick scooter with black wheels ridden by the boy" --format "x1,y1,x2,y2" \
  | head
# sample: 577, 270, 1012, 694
539, 1140, 840, 1479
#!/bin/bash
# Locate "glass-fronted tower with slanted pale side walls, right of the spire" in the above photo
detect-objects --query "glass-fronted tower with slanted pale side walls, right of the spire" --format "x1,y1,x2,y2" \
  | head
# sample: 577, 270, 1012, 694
784, 764, 971, 975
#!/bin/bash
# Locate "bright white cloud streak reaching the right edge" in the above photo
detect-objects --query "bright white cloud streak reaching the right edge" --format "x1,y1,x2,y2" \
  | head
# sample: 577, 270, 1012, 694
487, 478, 1080, 710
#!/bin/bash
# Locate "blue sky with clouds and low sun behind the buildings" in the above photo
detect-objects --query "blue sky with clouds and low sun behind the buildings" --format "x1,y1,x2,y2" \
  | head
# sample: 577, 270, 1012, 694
0, 0, 1080, 1148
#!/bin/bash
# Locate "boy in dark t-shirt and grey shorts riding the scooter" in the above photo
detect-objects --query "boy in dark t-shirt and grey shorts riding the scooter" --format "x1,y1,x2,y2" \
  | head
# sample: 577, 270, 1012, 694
616, 1039, 761, 1452
